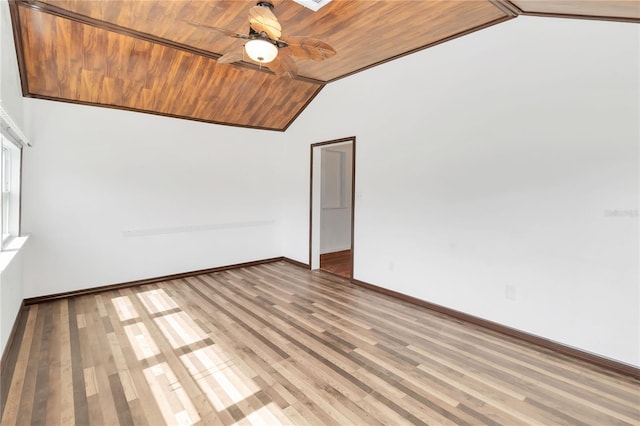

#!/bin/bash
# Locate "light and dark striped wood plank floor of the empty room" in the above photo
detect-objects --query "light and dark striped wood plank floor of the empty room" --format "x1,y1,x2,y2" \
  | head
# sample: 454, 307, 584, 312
0, 262, 640, 425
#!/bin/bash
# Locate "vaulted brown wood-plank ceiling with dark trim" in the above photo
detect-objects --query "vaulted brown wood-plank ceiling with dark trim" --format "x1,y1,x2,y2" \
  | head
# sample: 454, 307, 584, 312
10, 0, 640, 130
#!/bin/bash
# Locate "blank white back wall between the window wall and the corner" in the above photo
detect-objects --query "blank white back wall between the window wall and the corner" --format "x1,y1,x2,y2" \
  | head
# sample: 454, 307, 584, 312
23, 99, 283, 298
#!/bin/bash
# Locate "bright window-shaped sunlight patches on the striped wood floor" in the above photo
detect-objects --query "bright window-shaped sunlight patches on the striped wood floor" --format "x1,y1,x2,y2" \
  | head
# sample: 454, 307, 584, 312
131, 289, 287, 425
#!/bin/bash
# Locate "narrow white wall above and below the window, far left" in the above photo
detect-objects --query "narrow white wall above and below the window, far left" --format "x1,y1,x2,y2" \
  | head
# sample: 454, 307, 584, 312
0, 0, 23, 354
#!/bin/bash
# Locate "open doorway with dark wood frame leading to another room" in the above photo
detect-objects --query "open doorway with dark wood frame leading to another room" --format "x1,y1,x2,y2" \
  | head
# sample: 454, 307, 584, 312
309, 136, 356, 279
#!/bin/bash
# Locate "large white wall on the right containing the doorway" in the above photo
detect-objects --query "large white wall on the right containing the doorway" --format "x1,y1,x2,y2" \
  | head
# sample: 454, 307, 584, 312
284, 17, 640, 366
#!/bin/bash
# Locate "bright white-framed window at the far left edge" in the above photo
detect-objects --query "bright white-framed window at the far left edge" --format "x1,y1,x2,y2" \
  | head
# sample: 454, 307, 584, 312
0, 136, 22, 245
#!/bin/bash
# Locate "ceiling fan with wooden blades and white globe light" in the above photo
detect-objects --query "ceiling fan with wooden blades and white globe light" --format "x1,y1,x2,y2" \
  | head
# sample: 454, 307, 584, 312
185, 1, 336, 78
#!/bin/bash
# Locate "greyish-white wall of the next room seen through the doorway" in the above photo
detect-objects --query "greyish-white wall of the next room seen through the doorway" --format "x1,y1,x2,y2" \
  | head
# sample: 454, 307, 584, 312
320, 143, 353, 254
